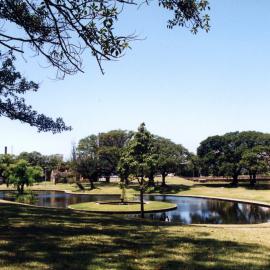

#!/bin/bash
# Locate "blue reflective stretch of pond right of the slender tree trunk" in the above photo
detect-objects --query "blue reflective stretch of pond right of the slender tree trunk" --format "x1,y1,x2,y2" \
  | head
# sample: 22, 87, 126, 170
142, 195, 270, 224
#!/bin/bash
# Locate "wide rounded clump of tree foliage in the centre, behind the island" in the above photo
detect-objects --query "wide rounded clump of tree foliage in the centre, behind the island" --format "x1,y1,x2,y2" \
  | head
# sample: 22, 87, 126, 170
73, 125, 191, 190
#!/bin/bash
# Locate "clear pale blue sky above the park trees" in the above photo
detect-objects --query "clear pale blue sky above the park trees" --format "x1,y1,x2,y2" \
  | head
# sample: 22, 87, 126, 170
0, 0, 270, 157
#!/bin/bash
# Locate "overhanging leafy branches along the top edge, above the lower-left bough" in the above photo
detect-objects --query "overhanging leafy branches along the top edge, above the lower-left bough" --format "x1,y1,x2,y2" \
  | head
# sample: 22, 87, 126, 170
0, 0, 209, 74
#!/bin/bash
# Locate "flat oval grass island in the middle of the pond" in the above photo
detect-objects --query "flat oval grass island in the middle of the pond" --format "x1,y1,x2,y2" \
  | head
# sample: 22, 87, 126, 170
69, 201, 176, 213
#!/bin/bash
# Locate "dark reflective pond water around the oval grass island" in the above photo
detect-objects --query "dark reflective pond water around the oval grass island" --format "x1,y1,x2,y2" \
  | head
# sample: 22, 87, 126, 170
0, 191, 270, 224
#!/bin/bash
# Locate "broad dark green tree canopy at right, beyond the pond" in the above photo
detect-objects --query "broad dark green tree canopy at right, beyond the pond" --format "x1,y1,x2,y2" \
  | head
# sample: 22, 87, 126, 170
198, 131, 270, 185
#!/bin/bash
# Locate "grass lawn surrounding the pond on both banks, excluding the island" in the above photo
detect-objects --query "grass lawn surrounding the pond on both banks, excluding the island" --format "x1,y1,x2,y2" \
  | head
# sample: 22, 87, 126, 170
0, 178, 270, 270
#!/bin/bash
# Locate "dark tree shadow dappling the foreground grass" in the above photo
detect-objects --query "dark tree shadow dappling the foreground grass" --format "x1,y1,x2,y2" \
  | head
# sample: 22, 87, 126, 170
0, 205, 270, 270
